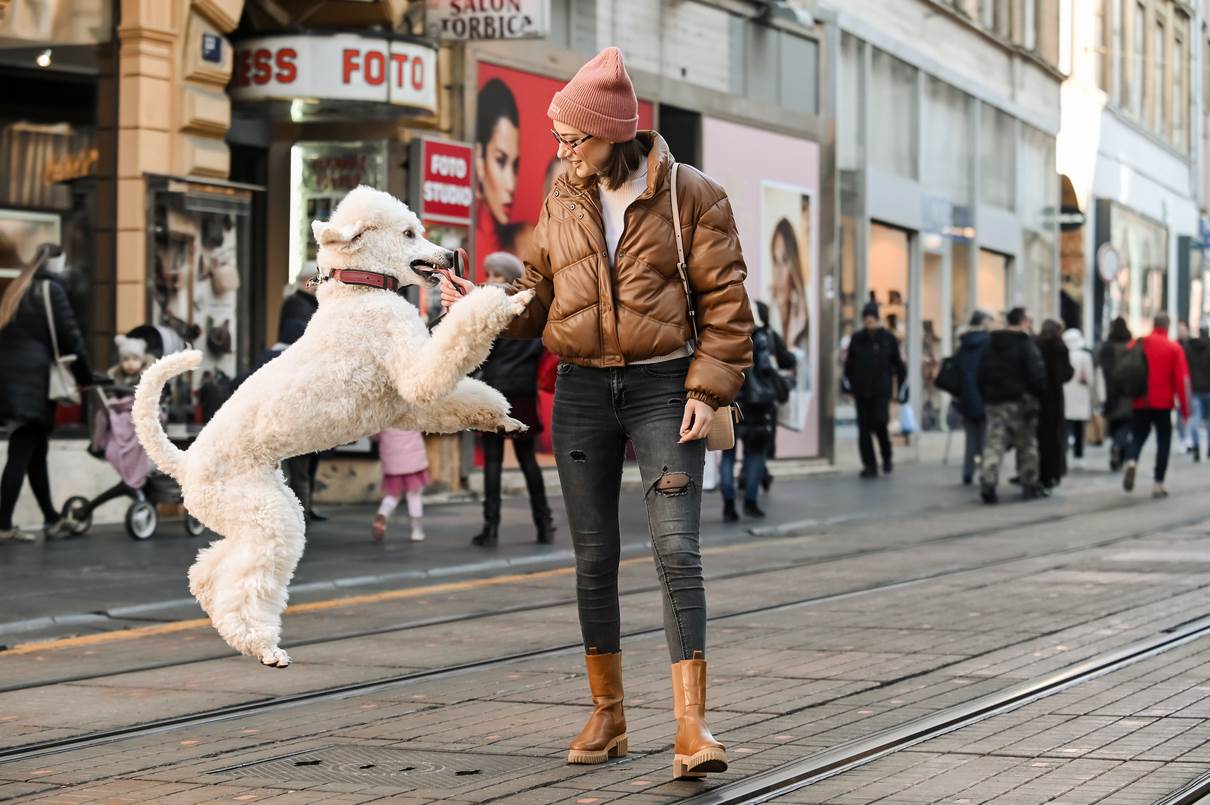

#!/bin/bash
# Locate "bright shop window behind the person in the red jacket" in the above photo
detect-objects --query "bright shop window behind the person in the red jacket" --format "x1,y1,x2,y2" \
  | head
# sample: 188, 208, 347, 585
1102, 205, 1168, 333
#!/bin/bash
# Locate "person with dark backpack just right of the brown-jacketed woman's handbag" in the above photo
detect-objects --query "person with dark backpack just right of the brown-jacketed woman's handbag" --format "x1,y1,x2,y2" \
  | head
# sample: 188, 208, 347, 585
719, 297, 797, 523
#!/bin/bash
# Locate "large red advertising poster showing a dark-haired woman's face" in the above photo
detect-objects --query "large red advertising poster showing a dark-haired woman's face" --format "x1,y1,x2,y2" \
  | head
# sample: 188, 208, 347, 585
472, 62, 655, 453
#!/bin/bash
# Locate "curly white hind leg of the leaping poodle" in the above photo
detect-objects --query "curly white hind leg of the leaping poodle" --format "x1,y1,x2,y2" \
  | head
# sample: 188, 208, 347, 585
190, 471, 306, 668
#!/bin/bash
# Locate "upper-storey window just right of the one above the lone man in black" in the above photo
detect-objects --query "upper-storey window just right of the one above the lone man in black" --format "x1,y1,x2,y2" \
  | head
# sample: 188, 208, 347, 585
922, 76, 974, 203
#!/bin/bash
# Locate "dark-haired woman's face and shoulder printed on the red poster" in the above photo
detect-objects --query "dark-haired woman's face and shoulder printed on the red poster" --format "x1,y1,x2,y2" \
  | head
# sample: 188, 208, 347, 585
474, 79, 529, 276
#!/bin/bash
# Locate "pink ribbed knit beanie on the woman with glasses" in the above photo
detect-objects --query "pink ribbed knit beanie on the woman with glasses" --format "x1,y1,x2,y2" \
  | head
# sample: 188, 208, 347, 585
546, 47, 639, 143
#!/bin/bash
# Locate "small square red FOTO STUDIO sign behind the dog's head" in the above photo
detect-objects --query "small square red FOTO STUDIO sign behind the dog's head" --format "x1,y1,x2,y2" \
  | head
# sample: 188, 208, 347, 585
408, 137, 474, 226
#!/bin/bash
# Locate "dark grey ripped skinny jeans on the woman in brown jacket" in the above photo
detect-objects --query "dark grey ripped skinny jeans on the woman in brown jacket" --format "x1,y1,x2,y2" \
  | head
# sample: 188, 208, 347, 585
551, 357, 705, 662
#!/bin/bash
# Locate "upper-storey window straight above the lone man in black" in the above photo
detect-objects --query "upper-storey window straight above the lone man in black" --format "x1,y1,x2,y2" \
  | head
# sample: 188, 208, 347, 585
869, 48, 917, 179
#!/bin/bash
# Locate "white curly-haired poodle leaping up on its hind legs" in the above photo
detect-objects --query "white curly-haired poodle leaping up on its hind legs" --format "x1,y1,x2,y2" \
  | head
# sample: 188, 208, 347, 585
134, 186, 532, 668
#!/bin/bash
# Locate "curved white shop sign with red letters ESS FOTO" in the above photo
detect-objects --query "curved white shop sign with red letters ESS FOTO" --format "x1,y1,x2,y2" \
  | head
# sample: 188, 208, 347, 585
229, 34, 437, 113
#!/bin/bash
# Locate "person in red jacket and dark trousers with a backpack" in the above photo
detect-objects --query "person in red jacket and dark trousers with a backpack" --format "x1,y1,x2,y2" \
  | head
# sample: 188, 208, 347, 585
1114, 314, 1189, 498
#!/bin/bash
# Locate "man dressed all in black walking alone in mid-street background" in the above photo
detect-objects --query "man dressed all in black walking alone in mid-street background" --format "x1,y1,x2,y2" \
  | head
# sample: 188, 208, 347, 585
845, 301, 908, 478
